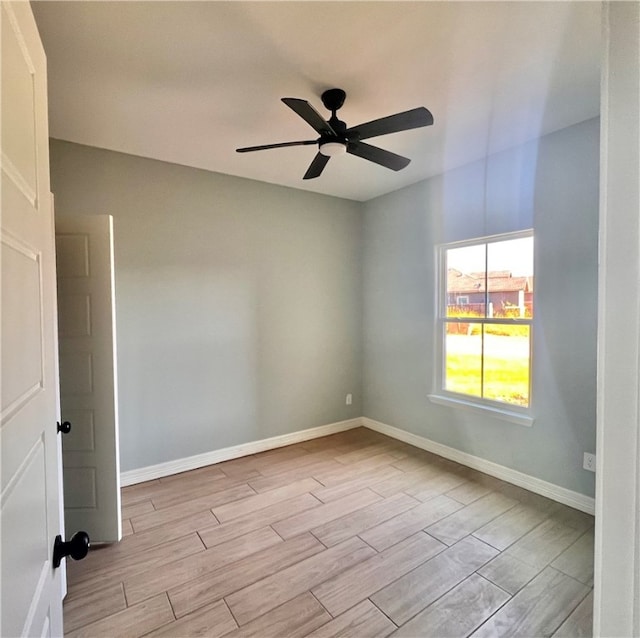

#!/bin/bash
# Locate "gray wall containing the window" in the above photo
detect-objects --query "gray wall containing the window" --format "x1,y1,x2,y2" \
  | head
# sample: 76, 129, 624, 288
363, 119, 599, 495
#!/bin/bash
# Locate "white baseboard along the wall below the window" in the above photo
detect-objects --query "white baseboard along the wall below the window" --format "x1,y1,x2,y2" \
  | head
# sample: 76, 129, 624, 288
362, 417, 595, 514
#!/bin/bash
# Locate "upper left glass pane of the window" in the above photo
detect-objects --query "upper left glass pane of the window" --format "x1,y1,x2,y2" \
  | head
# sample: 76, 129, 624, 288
444, 244, 486, 317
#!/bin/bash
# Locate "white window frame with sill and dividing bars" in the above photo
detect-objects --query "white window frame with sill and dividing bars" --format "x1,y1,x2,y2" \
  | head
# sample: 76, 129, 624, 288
428, 229, 535, 426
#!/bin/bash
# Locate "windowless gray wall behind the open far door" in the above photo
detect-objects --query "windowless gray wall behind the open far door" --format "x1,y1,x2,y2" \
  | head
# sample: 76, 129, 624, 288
51, 140, 362, 470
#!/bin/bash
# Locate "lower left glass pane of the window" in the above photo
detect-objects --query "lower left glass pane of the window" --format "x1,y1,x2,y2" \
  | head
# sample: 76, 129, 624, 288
444, 322, 482, 397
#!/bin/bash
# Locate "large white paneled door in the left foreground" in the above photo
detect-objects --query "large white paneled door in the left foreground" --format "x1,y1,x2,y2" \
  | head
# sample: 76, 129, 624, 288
0, 2, 62, 636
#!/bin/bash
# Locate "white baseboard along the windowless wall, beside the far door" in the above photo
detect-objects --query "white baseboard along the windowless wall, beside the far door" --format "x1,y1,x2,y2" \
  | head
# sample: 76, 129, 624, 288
120, 417, 362, 487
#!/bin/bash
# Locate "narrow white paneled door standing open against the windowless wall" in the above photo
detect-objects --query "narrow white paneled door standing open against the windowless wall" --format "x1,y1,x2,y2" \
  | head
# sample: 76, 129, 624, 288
56, 215, 121, 542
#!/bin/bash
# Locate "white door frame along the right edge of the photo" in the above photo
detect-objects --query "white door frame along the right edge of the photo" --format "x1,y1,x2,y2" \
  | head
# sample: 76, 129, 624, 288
593, 1, 640, 636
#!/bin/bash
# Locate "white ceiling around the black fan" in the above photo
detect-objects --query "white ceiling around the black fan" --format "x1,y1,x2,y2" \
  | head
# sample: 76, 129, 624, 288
32, 1, 600, 201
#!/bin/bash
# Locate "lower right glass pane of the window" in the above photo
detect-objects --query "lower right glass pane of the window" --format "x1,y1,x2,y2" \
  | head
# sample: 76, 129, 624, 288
483, 323, 530, 407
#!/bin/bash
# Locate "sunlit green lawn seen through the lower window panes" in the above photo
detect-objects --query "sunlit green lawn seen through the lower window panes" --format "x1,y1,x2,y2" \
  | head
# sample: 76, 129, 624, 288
445, 334, 529, 407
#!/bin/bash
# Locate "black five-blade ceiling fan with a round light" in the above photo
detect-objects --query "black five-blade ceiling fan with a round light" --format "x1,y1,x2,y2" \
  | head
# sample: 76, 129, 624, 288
236, 89, 433, 179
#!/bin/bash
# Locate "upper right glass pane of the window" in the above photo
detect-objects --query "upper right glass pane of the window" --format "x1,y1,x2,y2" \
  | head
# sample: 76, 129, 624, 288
487, 237, 533, 317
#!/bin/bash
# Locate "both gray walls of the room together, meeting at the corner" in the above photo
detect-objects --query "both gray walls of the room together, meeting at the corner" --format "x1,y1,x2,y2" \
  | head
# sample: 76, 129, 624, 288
51, 120, 599, 495
